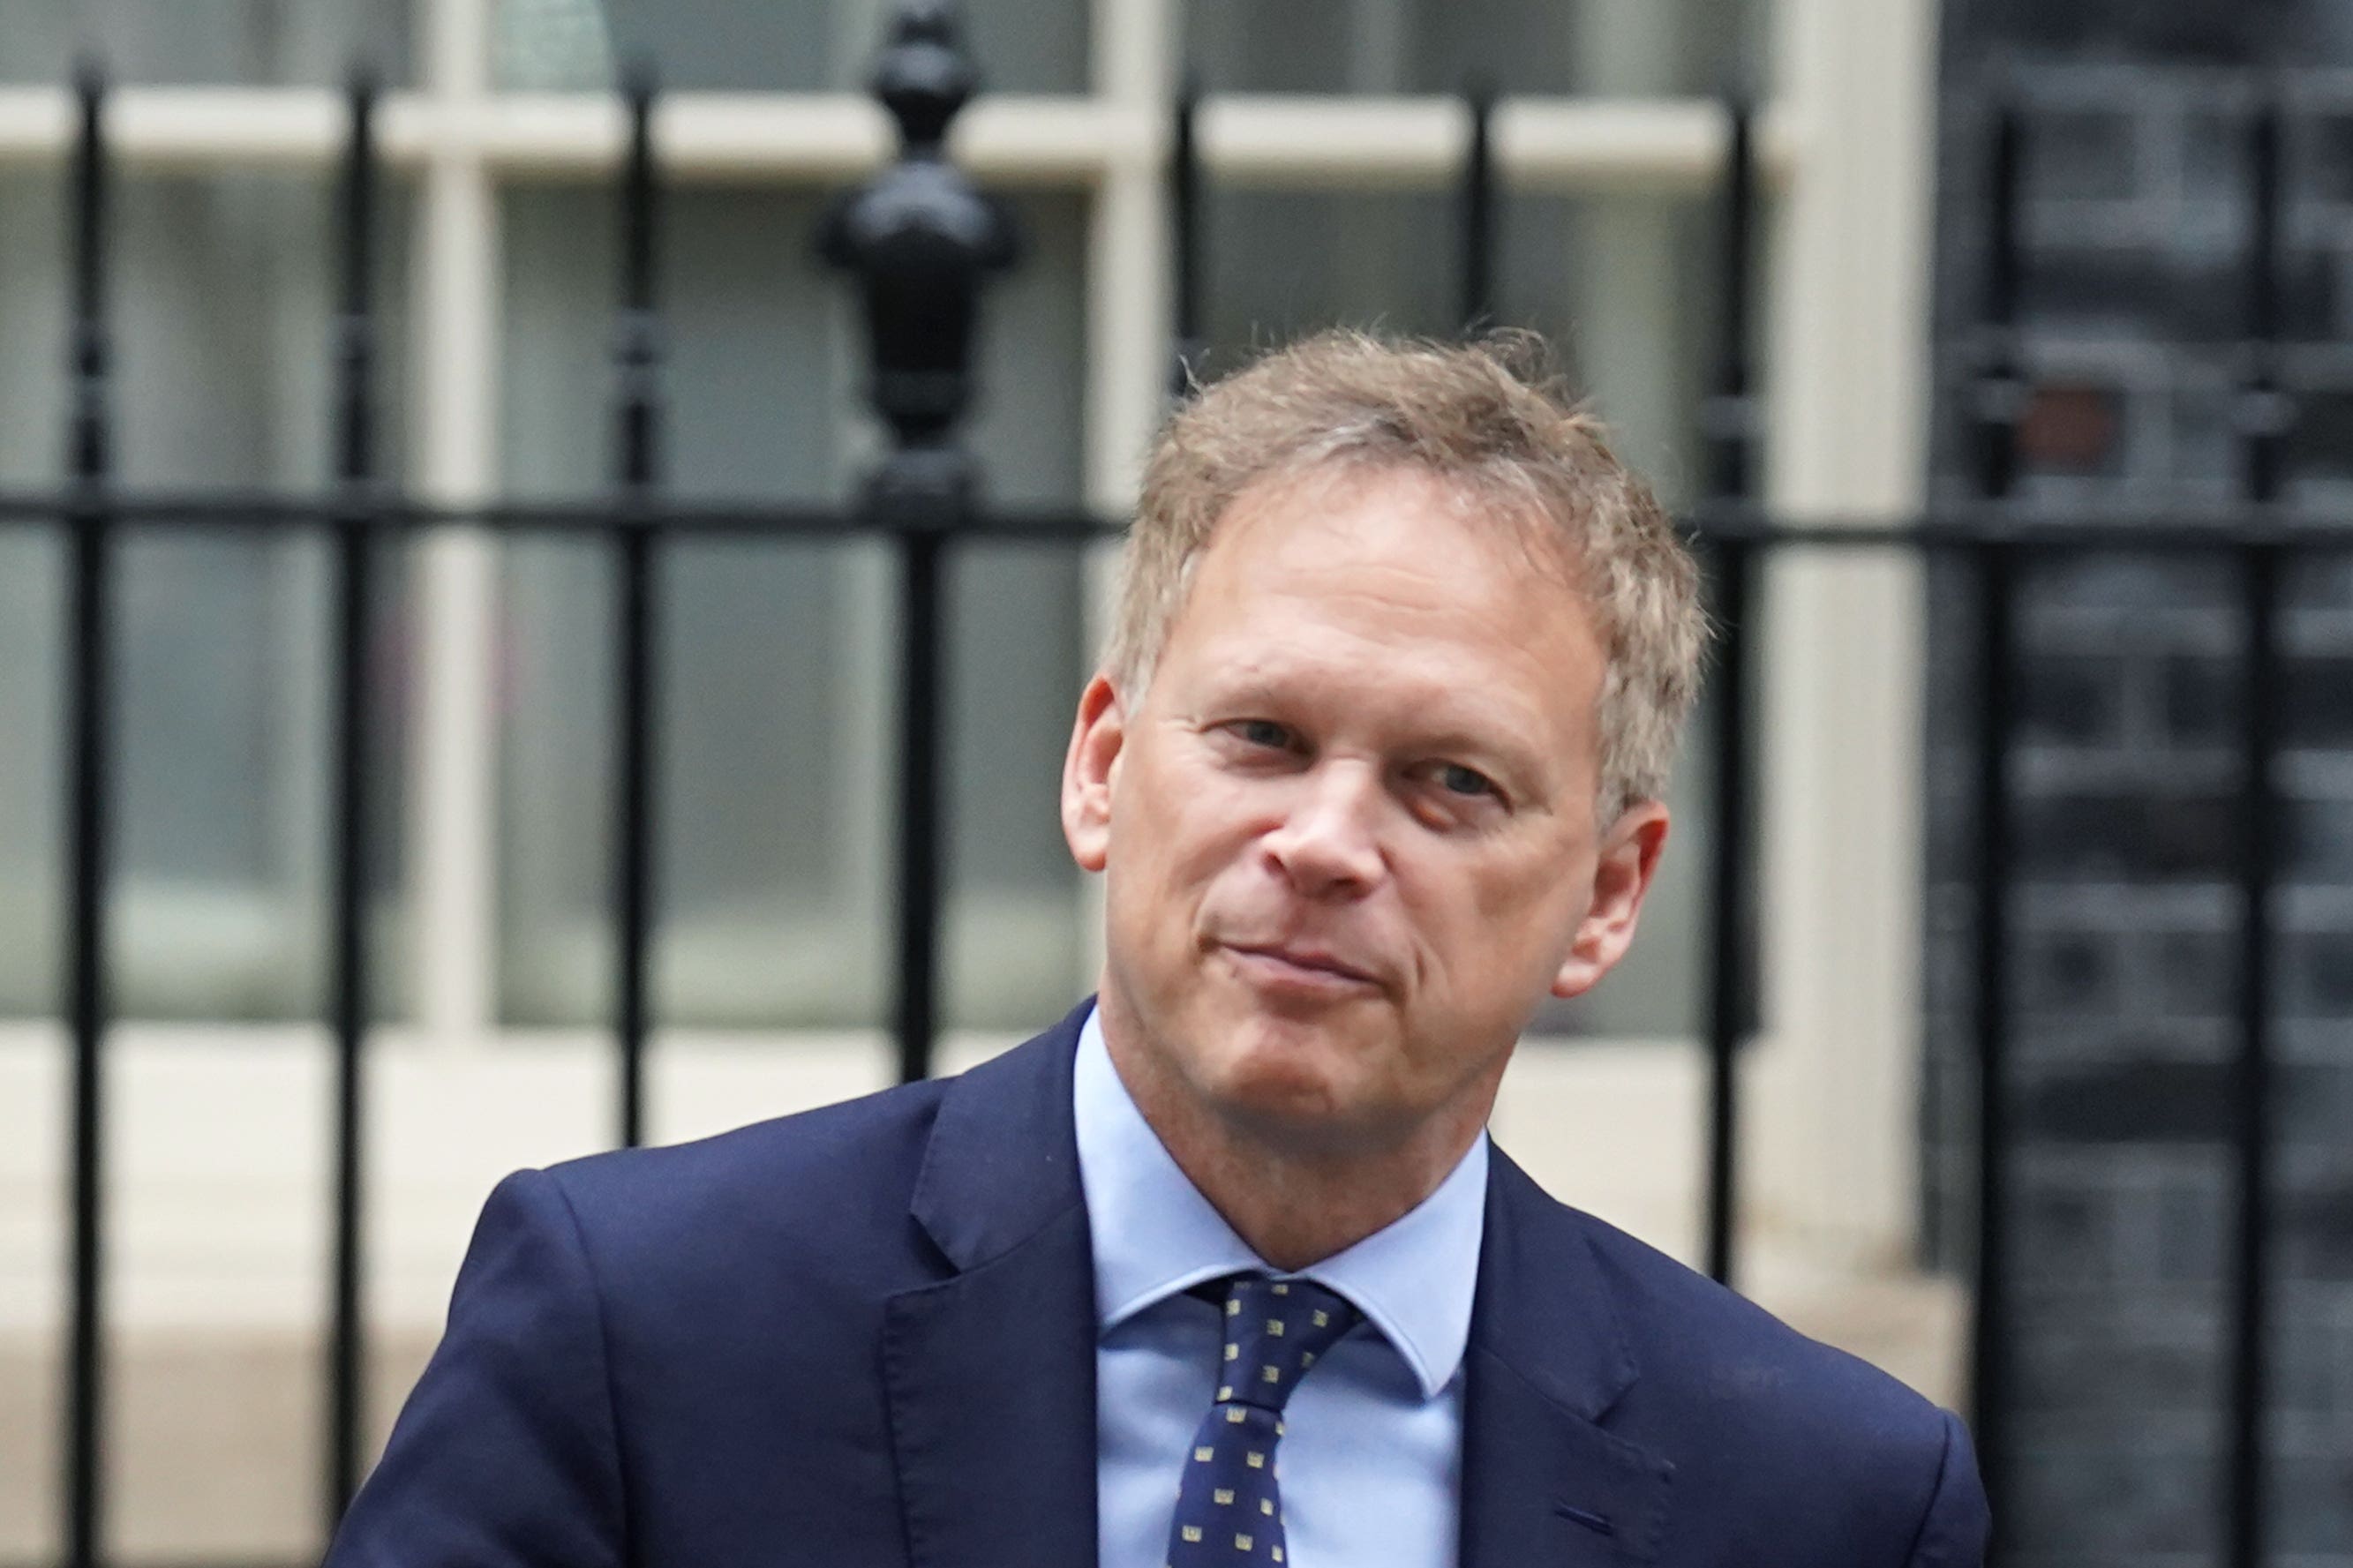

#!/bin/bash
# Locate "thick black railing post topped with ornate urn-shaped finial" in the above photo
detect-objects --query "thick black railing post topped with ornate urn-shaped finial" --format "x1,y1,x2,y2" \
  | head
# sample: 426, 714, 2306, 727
819, 0, 1019, 1082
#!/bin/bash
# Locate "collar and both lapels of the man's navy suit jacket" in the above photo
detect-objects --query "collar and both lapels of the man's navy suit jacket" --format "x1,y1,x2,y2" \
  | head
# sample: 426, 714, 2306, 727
883, 1004, 1673, 1568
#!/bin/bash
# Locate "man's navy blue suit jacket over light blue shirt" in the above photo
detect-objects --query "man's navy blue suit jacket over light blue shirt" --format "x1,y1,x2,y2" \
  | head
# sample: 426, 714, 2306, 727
327, 1011, 1986, 1568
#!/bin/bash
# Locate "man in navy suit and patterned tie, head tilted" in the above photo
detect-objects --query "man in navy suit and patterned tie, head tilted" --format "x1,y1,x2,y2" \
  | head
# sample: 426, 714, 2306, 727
332, 334, 1986, 1568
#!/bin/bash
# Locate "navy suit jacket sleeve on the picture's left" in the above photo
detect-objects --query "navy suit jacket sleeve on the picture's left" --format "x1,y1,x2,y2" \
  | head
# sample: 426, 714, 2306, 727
327, 1171, 626, 1568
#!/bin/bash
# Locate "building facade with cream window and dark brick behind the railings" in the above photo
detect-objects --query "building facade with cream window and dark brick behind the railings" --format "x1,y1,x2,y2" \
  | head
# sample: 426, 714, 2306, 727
18, 0, 2353, 1568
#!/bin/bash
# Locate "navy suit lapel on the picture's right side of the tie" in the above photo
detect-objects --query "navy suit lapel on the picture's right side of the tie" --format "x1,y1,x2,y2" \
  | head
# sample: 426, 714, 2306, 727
1462, 1152, 1673, 1568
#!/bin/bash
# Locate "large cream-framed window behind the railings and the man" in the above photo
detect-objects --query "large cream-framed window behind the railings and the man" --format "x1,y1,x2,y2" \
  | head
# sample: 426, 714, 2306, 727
0, 0, 1932, 1312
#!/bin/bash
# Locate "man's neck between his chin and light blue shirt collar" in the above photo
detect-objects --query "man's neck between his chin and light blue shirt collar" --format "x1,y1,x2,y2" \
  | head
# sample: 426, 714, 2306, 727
1103, 1016, 1494, 1270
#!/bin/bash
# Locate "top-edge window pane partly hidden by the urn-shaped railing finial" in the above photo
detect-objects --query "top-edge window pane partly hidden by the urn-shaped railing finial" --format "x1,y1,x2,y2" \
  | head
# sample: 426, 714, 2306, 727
492, 0, 1089, 92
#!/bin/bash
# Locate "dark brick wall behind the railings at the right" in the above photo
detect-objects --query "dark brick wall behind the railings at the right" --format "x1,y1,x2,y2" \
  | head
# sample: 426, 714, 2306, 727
1925, 0, 2353, 1568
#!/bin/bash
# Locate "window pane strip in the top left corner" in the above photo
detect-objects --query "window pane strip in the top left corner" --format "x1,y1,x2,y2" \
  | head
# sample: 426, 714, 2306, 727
0, 0, 417, 87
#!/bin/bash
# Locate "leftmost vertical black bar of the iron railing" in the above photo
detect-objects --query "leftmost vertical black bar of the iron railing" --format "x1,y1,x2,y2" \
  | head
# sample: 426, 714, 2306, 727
64, 66, 113, 1568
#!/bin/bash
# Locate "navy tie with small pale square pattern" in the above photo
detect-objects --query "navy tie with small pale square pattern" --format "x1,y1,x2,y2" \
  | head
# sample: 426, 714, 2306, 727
1167, 1274, 1363, 1568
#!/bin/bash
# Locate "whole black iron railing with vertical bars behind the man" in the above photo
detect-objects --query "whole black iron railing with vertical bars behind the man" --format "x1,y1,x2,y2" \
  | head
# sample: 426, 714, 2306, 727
0, 4, 2353, 1568
